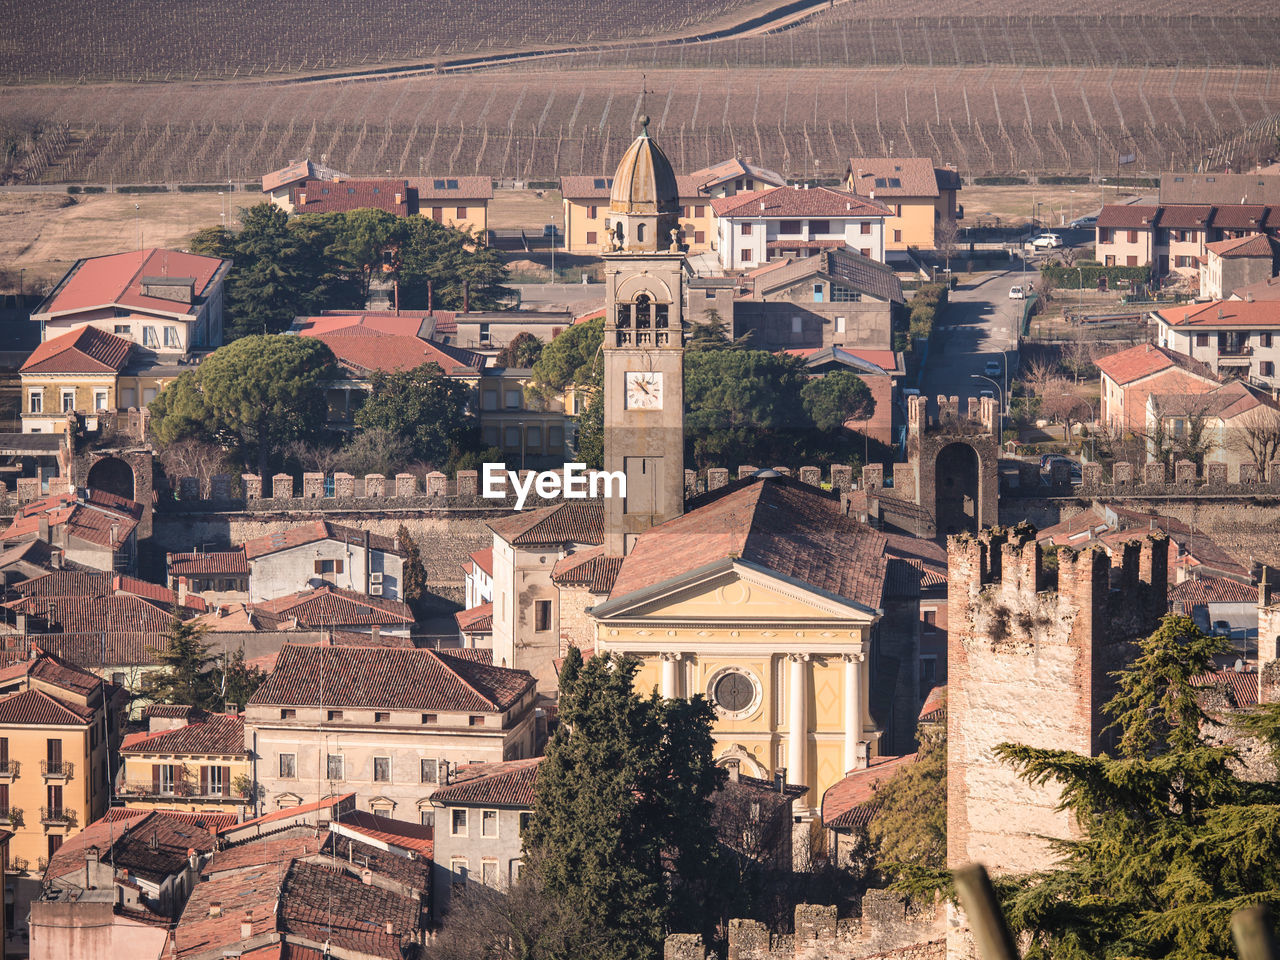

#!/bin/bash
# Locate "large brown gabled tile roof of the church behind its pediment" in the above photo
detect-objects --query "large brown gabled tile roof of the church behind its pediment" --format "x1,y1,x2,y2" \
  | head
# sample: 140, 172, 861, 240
611, 477, 888, 609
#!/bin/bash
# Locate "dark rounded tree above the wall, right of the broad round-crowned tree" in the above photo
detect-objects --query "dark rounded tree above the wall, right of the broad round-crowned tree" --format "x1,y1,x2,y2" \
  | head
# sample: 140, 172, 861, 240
356, 364, 480, 467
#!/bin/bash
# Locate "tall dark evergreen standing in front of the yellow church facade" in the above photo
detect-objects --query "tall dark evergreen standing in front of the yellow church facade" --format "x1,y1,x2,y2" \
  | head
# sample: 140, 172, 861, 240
525, 648, 723, 960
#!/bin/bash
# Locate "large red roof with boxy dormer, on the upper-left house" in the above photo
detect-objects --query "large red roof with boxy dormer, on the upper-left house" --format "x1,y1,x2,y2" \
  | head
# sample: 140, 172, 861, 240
36, 247, 232, 320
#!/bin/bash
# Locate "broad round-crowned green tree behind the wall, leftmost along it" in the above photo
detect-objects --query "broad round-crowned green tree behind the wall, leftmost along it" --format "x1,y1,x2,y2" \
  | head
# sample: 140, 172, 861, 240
151, 335, 337, 475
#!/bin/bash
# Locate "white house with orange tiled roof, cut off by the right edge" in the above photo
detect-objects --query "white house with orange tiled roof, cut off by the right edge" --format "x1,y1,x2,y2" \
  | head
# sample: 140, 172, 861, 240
1151, 300, 1280, 389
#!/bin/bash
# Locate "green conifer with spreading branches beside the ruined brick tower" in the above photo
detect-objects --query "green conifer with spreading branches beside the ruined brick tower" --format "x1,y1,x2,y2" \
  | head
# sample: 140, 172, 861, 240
998, 614, 1280, 960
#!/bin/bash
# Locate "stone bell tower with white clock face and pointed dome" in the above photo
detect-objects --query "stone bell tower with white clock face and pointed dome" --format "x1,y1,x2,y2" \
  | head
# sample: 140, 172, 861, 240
604, 116, 685, 557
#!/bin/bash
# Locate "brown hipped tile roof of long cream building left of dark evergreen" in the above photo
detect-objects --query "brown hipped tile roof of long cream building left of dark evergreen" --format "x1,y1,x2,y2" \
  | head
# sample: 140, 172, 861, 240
250, 644, 534, 713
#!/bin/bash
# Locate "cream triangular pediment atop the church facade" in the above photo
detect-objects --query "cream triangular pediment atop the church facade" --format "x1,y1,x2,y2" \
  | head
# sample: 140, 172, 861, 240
593, 561, 877, 625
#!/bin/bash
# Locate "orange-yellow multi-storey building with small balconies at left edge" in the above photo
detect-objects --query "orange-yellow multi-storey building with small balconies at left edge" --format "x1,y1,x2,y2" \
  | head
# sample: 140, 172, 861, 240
0, 654, 118, 899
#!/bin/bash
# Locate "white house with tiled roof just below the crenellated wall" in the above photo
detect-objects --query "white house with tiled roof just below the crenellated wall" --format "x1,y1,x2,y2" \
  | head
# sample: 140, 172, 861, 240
241, 520, 404, 603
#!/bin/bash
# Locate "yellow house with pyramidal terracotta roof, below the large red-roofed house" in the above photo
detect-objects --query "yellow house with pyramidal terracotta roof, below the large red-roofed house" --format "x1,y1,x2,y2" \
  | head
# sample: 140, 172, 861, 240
18, 325, 133, 434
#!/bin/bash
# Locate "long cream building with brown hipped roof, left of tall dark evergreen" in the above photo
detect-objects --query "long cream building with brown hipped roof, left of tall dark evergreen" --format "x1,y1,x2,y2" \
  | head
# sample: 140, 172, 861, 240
244, 644, 536, 823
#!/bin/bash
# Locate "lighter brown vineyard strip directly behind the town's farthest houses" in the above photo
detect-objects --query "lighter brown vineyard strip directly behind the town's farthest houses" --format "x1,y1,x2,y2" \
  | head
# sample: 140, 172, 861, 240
0, 67, 1280, 183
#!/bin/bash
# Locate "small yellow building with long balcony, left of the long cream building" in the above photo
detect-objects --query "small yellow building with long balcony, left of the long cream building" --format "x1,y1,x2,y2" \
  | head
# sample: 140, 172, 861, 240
116, 704, 252, 813
